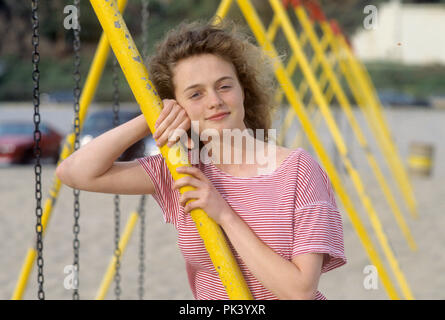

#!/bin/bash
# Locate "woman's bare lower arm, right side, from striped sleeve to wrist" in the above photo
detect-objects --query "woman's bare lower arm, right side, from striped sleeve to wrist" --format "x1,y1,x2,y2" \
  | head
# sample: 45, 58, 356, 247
221, 209, 324, 300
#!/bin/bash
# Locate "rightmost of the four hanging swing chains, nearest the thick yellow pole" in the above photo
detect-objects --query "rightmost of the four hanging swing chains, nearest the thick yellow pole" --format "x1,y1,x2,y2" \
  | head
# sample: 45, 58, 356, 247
138, 0, 149, 300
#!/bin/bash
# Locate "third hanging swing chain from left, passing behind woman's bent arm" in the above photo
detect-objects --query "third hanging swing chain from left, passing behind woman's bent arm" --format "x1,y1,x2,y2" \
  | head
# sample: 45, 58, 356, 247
113, 53, 121, 300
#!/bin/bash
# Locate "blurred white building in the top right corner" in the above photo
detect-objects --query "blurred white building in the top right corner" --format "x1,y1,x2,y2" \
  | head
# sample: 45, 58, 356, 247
351, 0, 445, 64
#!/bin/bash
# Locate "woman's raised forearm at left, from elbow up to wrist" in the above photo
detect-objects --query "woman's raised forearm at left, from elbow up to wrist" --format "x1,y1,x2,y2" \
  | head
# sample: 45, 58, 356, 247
57, 114, 150, 183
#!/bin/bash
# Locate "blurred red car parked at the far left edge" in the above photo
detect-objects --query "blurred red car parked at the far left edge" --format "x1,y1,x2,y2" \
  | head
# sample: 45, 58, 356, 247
0, 121, 63, 164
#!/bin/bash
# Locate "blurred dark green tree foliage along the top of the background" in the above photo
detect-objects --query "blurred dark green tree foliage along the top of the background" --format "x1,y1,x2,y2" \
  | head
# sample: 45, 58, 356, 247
0, 0, 396, 59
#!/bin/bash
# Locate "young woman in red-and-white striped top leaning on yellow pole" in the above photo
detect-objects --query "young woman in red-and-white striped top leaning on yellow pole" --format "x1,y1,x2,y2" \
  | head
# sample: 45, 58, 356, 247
56, 23, 346, 299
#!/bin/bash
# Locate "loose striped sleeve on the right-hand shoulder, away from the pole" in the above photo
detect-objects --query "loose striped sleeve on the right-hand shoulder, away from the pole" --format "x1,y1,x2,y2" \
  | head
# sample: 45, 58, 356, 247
292, 150, 346, 272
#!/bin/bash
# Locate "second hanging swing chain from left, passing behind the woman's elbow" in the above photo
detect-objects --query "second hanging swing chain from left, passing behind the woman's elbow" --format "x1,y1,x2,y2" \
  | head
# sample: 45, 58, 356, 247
73, 0, 80, 300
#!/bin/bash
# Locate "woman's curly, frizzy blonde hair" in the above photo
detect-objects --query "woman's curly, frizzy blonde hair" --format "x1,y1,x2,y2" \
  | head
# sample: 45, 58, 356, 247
147, 21, 276, 142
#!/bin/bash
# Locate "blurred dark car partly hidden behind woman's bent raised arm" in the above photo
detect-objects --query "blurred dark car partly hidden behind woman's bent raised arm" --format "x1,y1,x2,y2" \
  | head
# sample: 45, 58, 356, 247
79, 110, 160, 161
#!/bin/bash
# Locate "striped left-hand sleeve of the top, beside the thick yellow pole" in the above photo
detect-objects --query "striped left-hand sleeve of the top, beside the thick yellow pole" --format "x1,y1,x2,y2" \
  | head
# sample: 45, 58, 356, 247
136, 154, 180, 228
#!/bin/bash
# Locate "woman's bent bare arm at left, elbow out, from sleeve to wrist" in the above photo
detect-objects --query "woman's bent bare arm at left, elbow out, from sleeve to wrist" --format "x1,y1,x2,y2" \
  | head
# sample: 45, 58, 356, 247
56, 114, 154, 194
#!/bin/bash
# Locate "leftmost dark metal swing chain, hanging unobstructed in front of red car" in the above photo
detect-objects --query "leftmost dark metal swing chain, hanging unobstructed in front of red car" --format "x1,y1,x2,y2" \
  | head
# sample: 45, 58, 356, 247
31, 0, 45, 300
